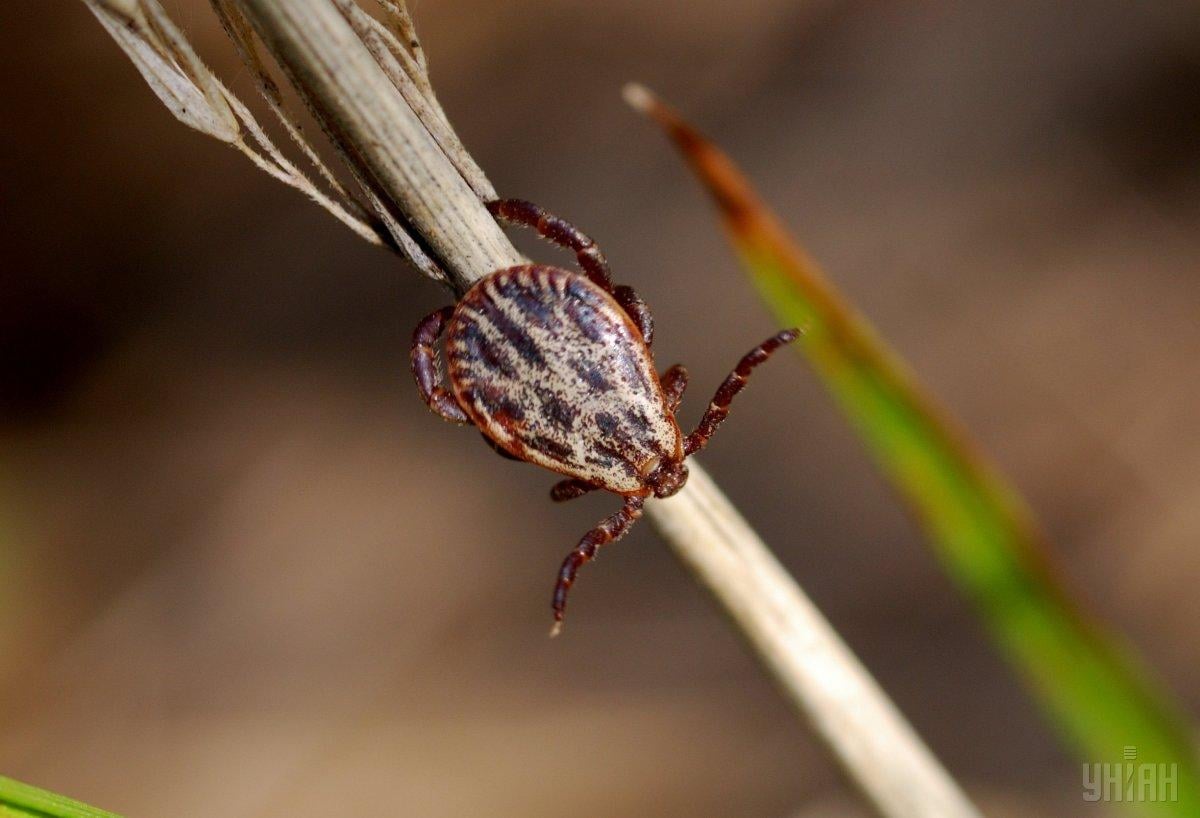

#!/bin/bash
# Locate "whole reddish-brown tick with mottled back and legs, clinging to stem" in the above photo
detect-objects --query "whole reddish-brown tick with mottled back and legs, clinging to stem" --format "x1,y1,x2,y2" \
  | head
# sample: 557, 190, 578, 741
412, 199, 799, 633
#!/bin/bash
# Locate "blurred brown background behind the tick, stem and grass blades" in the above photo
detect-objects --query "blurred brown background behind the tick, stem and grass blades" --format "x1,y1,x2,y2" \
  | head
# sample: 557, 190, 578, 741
0, 0, 1200, 818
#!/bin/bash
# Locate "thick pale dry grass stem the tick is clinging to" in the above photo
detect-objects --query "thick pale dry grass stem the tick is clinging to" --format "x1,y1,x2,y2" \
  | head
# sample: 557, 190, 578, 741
84, 0, 978, 818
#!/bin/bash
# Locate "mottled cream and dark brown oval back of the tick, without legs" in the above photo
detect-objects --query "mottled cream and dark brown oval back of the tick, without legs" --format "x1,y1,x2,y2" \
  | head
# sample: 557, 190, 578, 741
445, 265, 683, 494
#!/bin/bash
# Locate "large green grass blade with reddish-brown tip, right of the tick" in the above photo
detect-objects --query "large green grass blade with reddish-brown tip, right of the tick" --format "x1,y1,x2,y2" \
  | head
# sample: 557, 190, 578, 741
626, 86, 1200, 818
